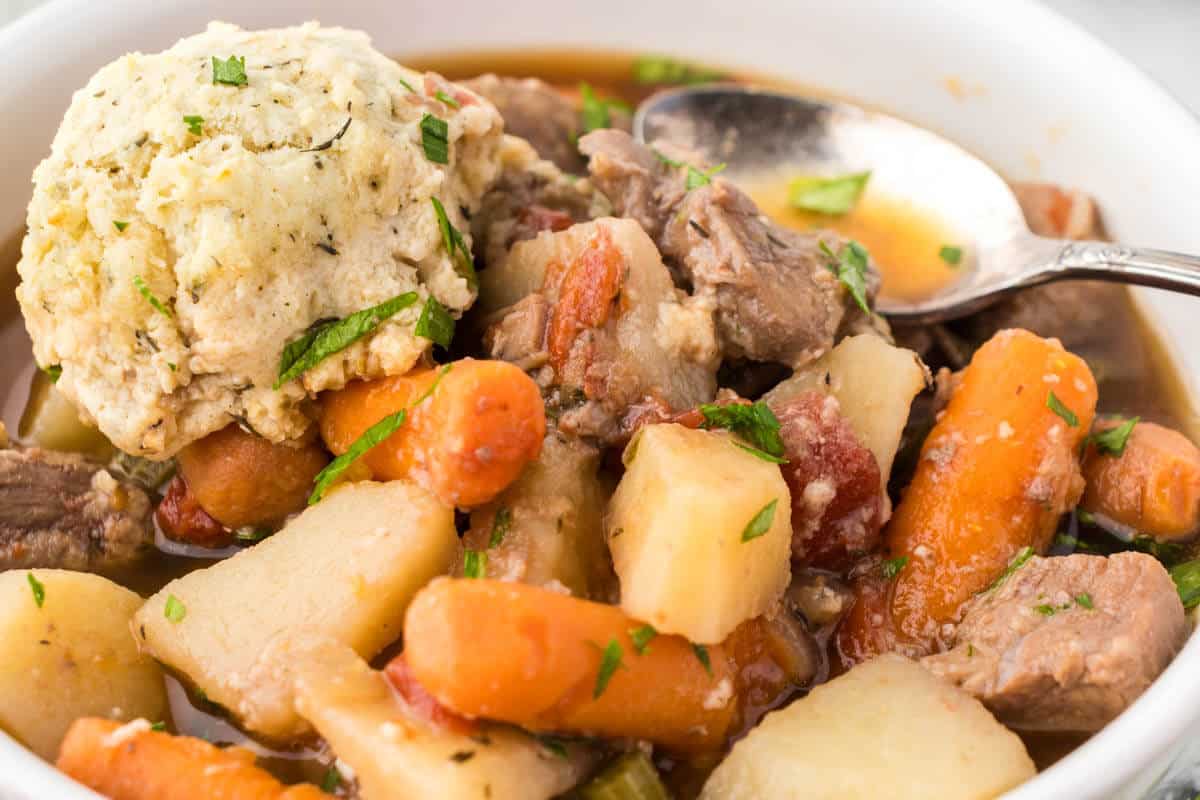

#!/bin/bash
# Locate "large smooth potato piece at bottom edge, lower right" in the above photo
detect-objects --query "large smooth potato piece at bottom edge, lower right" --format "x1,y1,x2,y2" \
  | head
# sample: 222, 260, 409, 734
701, 655, 1036, 800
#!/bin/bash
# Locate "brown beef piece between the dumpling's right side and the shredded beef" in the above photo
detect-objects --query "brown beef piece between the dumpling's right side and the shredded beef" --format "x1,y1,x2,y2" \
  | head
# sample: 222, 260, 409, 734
470, 137, 610, 266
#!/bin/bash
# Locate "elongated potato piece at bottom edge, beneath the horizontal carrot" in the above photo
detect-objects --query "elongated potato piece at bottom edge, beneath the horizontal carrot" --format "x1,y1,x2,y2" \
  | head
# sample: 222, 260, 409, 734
292, 642, 595, 800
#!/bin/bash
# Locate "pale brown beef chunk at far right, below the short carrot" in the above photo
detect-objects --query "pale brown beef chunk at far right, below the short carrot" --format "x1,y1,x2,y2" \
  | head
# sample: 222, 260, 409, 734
922, 553, 1188, 732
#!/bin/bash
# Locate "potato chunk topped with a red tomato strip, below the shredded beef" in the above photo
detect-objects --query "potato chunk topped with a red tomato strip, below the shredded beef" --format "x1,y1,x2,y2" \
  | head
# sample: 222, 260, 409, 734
480, 218, 718, 444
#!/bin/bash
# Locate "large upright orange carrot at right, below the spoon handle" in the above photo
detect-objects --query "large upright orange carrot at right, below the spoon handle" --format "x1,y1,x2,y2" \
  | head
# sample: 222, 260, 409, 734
839, 330, 1096, 656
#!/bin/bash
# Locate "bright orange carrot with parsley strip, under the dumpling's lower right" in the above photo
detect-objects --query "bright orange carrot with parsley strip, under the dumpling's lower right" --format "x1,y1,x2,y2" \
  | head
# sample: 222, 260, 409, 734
320, 359, 546, 506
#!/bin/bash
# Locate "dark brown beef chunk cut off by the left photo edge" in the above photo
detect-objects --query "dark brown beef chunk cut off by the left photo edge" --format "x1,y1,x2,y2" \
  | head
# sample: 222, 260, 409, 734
0, 449, 154, 572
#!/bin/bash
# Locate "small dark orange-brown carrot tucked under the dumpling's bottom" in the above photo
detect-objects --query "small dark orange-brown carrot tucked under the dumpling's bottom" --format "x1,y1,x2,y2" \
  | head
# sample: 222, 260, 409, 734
179, 425, 329, 528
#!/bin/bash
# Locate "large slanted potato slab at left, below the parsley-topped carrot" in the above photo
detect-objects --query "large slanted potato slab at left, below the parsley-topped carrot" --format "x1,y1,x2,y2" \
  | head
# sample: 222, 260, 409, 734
136, 481, 458, 739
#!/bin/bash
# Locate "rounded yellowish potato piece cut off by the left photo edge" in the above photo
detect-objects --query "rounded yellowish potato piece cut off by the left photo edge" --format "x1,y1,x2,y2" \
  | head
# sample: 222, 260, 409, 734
0, 570, 167, 760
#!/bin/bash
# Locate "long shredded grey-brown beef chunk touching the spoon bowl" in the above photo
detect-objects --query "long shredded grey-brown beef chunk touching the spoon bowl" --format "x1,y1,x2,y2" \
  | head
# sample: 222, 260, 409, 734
580, 130, 878, 367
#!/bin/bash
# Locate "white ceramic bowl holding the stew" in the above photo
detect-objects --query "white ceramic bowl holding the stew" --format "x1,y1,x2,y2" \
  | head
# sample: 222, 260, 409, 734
0, 0, 1200, 800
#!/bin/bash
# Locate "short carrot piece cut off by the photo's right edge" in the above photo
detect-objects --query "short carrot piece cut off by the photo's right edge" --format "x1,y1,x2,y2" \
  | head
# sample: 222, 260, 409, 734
1080, 421, 1200, 541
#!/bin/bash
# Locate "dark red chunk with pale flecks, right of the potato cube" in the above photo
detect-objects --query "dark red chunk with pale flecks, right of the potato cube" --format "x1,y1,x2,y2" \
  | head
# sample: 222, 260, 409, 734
774, 391, 883, 570
